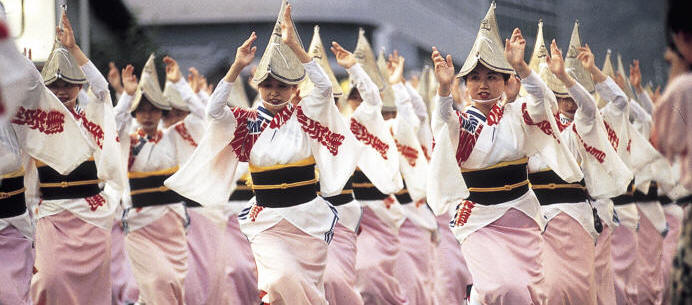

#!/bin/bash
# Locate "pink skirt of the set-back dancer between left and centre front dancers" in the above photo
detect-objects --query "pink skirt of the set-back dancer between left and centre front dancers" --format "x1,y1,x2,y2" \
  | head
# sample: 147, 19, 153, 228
125, 210, 188, 305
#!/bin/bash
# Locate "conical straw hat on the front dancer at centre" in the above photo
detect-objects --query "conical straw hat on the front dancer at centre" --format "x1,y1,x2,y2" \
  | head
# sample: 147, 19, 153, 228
252, 0, 305, 85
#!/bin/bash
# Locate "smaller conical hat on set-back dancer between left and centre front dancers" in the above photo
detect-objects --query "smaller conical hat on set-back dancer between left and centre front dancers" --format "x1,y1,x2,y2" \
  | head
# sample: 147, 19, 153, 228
130, 54, 171, 112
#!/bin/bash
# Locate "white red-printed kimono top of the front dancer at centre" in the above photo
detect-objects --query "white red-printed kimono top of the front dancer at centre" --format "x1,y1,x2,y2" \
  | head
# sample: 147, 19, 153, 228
165, 58, 358, 241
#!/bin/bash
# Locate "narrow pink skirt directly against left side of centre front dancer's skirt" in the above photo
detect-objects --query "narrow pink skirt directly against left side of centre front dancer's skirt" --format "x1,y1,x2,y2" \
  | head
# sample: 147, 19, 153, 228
224, 215, 259, 304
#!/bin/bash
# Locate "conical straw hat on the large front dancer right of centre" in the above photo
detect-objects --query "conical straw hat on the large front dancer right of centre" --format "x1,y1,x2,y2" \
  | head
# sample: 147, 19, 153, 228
457, 2, 513, 77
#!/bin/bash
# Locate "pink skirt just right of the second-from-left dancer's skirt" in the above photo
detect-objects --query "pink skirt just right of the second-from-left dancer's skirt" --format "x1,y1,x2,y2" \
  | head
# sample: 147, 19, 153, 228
184, 208, 232, 305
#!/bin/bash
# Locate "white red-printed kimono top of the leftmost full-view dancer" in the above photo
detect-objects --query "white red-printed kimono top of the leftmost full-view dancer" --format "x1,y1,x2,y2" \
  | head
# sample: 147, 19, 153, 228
12, 62, 126, 231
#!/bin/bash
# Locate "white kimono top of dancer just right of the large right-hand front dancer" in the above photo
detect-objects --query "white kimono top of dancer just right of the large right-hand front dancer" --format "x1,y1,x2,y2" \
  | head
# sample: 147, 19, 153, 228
529, 83, 632, 239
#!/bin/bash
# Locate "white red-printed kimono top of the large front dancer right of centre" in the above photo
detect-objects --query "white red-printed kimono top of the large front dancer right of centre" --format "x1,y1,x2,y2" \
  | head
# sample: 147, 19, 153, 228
427, 72, 582, 243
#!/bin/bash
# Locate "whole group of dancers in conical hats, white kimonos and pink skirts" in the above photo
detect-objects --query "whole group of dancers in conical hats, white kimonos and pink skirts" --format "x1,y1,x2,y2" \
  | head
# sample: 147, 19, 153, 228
2, 3, 689, 304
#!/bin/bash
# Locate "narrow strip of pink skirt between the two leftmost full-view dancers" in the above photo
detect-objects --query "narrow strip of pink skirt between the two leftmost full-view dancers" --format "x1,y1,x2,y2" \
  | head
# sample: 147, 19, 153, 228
111, 222, 139, 305
